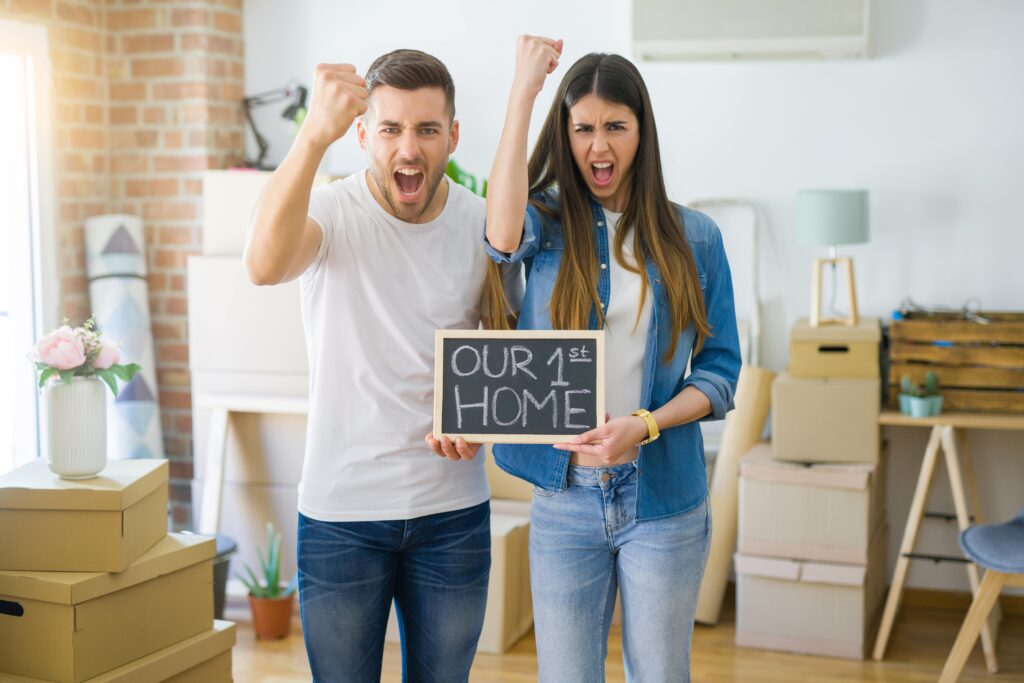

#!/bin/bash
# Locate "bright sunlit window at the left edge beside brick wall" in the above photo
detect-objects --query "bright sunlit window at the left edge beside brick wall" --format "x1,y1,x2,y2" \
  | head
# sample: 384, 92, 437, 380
0, 22, 56, 472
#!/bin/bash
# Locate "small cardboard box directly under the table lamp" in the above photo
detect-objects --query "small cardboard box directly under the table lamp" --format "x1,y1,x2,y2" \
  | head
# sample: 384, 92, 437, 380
790, 317, 882, 378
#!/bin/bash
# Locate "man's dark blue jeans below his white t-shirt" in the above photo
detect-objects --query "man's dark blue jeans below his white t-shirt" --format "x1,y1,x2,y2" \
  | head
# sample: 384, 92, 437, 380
298, 503, 490, 683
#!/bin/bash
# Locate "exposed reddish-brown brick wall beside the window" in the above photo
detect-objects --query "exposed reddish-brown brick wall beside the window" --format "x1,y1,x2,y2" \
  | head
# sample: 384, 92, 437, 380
0, 0, 244, 527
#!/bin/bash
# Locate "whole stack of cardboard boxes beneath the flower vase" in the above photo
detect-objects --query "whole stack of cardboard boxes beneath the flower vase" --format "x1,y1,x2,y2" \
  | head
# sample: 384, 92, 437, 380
0, 460, 236, 683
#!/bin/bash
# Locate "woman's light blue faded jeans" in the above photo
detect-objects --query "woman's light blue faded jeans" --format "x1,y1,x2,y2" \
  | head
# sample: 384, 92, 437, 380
529, 463, 711, 683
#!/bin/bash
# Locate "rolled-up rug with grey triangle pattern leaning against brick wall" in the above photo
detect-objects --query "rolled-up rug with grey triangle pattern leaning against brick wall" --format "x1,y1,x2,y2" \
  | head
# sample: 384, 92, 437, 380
85, 215, 164, 459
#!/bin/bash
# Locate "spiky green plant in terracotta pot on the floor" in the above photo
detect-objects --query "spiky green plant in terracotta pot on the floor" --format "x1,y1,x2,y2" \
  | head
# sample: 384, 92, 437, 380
234, 522, 298, 640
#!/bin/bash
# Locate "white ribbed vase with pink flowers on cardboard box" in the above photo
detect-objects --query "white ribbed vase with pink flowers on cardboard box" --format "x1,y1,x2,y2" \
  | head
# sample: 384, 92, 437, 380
33, 317, 140, 479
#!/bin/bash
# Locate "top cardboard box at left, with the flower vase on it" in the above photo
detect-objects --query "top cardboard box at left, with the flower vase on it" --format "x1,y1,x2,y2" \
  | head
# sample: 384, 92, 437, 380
0, 459, 168, 571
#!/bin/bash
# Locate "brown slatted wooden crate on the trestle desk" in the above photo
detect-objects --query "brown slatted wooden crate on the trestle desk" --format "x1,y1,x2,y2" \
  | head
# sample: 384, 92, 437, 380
889, 312, 1024, 413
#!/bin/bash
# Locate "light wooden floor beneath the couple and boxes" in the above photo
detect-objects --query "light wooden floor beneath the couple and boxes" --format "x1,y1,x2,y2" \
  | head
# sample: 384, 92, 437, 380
225, 604, 1024, 683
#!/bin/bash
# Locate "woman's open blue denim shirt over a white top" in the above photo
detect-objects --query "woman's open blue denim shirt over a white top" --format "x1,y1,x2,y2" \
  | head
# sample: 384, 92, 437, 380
484, 193, 740, 521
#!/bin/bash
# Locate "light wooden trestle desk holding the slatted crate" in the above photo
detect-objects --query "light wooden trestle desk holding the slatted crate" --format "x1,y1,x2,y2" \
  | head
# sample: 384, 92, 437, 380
873, 411, 1024, 674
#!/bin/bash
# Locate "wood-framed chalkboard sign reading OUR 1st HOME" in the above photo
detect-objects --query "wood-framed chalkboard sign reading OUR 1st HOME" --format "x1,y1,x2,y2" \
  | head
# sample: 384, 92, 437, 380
434, 330, 604, 443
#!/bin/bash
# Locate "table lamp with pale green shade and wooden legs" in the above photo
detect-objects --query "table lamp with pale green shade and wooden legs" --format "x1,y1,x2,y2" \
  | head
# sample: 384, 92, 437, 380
797, 189, 868, 327
